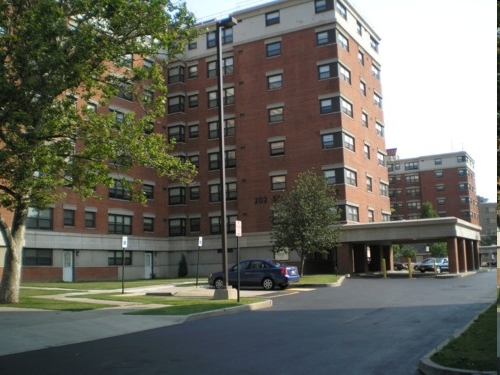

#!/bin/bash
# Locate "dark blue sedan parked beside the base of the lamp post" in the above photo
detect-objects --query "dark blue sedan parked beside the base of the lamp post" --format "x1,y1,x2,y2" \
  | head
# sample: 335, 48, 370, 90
208, 259, 300, 290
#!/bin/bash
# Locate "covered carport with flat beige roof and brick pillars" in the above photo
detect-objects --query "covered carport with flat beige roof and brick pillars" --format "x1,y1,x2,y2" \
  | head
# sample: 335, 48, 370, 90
337, 217, 481, 273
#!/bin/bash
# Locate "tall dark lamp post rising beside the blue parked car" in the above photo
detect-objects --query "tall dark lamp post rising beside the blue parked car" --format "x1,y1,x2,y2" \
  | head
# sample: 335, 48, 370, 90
215, 17, 238, 300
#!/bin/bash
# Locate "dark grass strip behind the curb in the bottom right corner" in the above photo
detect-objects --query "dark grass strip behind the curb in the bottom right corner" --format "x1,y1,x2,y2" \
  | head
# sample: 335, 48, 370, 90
431, 304, 497, 371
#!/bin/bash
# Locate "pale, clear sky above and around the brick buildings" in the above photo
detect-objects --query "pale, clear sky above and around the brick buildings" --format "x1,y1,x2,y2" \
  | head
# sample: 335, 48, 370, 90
185, 0, 497, 202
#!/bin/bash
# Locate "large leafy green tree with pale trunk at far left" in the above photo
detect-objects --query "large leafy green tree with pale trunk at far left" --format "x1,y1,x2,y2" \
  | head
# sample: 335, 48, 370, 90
0, 0, 196, 303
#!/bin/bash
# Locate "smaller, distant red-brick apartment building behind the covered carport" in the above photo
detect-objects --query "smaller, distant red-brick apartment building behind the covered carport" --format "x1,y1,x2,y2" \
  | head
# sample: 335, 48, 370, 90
387, 149, 479, 225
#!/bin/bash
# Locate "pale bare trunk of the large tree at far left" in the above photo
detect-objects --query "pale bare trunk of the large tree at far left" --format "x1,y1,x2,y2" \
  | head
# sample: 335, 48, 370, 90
0, 205, 28, 303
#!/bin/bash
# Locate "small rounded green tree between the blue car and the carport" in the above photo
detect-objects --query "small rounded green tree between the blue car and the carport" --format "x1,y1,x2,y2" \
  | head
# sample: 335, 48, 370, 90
271, 171, 340, 275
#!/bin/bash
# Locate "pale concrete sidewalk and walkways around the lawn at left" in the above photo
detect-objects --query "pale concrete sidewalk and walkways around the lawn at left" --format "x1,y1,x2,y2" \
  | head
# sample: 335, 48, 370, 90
0, 285, 272, 356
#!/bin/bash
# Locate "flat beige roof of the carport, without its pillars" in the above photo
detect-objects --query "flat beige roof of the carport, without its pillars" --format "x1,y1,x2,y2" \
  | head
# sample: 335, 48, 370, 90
340, 217, 481, 244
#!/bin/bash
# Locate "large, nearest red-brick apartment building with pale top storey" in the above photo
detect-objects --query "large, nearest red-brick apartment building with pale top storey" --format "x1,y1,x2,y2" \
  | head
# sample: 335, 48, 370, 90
0, 0, 394, 281
